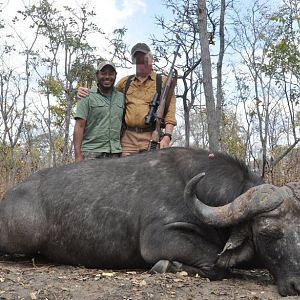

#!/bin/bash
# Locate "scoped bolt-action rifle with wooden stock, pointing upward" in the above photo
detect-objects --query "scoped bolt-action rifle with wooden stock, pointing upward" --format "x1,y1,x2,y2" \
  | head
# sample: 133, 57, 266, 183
145, 45, 180, 151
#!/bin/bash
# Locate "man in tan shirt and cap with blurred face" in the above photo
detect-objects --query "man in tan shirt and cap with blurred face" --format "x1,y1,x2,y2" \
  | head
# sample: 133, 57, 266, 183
78, 43, 176, 156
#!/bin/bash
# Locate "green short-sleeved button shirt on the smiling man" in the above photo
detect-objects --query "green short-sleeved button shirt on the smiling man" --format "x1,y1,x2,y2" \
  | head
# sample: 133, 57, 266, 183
75, 89, 124, 153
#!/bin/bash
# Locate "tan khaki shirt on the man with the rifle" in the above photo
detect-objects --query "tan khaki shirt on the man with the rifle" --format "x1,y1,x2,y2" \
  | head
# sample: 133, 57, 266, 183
116, 71, 176, 128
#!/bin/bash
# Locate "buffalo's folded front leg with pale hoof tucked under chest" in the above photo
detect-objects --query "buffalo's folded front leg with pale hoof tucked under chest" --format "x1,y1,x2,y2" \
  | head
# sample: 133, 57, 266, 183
141, 225, 225, 279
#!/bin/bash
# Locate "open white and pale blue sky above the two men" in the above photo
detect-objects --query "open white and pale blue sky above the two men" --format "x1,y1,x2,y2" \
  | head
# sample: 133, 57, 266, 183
0, 0, 171, 79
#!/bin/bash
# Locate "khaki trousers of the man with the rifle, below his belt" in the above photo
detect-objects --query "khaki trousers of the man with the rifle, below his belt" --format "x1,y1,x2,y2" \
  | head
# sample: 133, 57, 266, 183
121, 130, 152, 156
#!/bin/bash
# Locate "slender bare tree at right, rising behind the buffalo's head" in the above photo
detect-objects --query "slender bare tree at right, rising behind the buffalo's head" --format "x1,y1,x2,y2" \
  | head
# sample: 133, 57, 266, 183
232, 1, 295, 177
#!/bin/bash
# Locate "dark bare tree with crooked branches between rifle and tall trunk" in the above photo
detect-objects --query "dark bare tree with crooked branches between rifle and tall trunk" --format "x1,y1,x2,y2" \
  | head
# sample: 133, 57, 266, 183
152, 0, 202, 147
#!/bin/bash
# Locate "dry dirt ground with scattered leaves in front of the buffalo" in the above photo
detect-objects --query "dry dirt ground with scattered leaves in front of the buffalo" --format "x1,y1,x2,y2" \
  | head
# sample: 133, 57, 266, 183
0, 256, 300, 300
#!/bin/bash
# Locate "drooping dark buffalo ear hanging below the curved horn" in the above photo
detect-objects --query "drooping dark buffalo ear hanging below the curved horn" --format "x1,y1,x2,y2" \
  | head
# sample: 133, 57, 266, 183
217, 224, 254, 269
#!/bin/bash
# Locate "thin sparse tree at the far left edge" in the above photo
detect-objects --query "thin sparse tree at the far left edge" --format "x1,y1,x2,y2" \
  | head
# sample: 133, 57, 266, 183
0, 11, 37, 186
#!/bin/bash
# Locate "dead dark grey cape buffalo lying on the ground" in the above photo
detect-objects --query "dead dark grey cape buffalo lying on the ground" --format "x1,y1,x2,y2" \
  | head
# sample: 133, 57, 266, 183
0, 148, 300, 295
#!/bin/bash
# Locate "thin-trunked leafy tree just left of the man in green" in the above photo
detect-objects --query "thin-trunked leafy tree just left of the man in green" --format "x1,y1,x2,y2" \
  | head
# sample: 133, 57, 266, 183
19, 0, 102, 165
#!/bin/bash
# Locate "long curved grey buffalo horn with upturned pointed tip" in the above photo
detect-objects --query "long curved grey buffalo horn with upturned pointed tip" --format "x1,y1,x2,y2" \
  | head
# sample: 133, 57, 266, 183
184, 173, 285, 227
